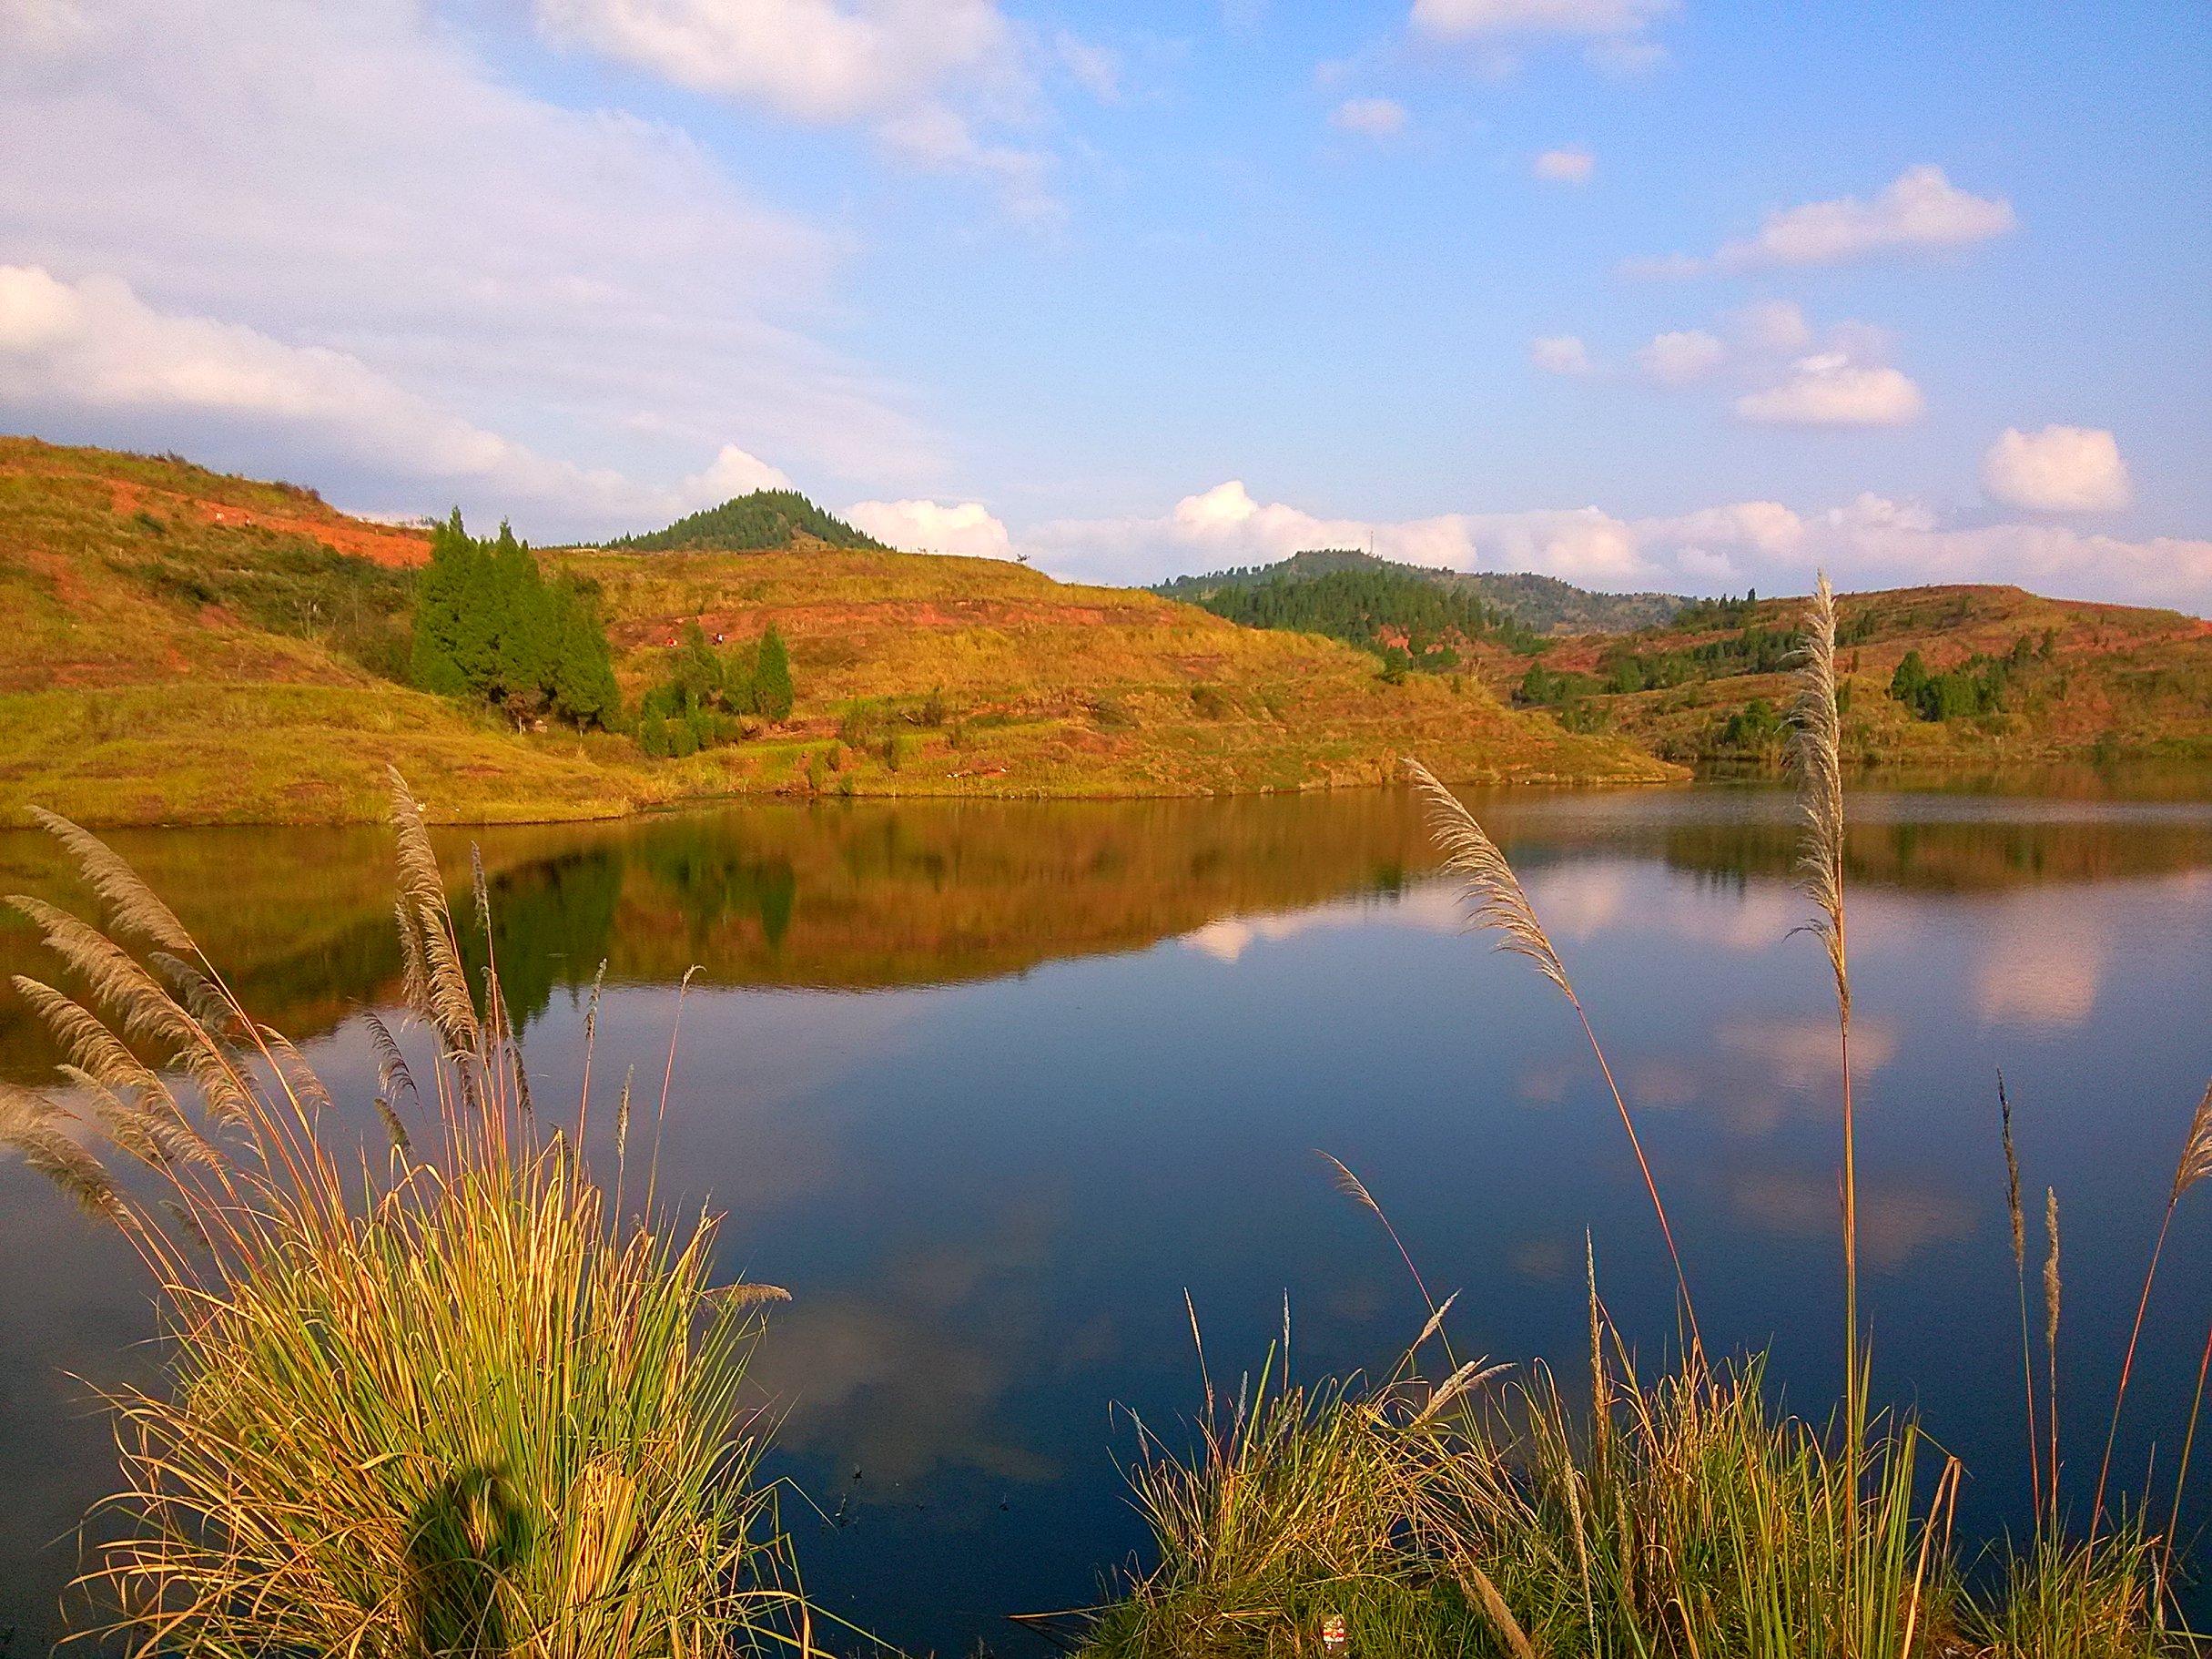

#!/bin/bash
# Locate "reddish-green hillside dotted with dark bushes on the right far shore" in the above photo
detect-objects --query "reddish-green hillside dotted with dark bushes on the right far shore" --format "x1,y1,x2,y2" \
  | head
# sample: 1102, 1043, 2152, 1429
1477, 586, 2212, 768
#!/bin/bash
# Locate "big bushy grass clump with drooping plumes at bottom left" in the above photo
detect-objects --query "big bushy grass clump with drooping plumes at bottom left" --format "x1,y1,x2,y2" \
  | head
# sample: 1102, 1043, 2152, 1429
0, 774, 812, 1659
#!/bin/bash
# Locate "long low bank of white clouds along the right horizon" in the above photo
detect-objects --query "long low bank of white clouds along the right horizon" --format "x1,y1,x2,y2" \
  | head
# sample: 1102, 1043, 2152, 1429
1020, 480, 2212, 615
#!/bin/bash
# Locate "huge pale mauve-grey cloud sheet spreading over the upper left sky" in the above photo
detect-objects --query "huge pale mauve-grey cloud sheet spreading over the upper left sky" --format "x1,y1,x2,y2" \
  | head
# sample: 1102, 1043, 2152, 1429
0, 0, 936, 537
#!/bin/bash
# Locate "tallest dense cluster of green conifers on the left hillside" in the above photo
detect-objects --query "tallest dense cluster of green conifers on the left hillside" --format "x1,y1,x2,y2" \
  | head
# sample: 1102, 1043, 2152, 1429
410, 517, 622, 728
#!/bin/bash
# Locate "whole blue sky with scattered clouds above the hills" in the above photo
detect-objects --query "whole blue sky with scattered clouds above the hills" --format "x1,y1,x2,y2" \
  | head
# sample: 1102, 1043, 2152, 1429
0, 0, 2212, 615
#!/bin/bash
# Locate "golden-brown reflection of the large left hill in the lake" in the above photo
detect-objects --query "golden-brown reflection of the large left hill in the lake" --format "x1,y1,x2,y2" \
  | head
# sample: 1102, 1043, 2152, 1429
0, 792, 1426, 1077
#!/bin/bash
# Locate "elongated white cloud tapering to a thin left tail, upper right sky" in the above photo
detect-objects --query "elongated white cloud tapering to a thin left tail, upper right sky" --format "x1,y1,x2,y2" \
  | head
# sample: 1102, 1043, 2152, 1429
1628, 166, 2020, 277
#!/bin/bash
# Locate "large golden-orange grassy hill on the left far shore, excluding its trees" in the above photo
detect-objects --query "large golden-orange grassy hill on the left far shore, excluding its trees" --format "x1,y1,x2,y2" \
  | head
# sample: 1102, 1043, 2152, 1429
0, 438, 1672, 825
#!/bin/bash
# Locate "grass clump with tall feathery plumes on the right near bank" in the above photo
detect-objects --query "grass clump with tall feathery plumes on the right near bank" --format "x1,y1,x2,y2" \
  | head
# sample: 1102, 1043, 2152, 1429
1091, 575, 2212, 1659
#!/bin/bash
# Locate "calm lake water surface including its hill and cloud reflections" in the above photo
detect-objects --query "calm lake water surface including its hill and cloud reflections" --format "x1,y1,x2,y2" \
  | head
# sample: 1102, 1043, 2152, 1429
0, 777, 2212, 1654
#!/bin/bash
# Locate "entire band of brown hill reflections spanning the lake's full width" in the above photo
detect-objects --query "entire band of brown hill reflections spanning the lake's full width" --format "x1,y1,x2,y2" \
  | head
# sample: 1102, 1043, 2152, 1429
0, 789, 2212, 1077
